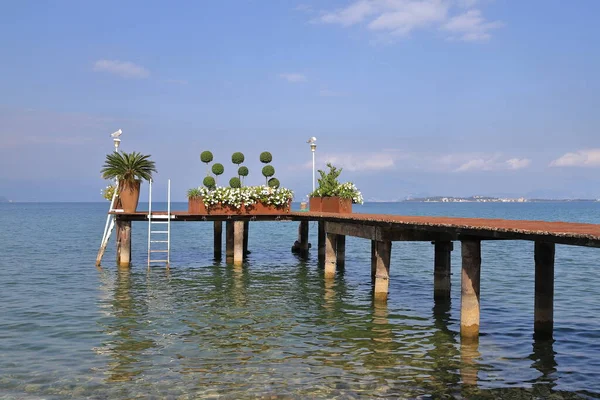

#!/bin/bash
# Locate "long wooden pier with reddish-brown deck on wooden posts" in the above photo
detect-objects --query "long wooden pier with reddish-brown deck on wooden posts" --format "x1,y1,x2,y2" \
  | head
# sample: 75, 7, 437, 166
108, 212, 600, 340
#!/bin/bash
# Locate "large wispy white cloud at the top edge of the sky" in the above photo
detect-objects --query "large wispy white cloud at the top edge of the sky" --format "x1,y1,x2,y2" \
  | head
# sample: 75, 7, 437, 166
315, 0, 502, 41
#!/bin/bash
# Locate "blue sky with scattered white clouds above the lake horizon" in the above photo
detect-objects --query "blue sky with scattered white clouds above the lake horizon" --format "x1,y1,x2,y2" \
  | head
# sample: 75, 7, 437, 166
0, 0, 600, 201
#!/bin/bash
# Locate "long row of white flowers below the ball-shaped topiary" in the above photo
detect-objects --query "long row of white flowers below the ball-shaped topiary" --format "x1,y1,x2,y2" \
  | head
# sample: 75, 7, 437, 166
198, 186, 294, 209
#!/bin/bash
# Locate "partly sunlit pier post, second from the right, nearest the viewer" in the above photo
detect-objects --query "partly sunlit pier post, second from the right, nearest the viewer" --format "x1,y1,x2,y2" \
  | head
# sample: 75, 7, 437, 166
460, 239, 481, 341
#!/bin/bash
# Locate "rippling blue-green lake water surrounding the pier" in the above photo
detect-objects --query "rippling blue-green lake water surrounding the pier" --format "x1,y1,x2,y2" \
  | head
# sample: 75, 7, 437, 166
0, 203, 600, 399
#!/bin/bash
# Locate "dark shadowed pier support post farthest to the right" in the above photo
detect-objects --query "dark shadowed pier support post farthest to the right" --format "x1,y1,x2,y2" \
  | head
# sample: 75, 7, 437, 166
533, 242, 555, 339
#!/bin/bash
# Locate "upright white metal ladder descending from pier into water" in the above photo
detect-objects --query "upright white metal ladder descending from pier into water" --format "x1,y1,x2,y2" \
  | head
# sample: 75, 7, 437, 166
148, 179, 172, 268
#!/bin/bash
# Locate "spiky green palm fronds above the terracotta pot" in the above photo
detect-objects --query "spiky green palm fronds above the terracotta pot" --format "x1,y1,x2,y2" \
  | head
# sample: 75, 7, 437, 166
100, 151, 157, 185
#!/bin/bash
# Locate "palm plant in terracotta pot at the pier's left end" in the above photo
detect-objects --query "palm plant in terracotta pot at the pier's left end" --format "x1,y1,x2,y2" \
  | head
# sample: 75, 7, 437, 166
100, 151, 157, 213
